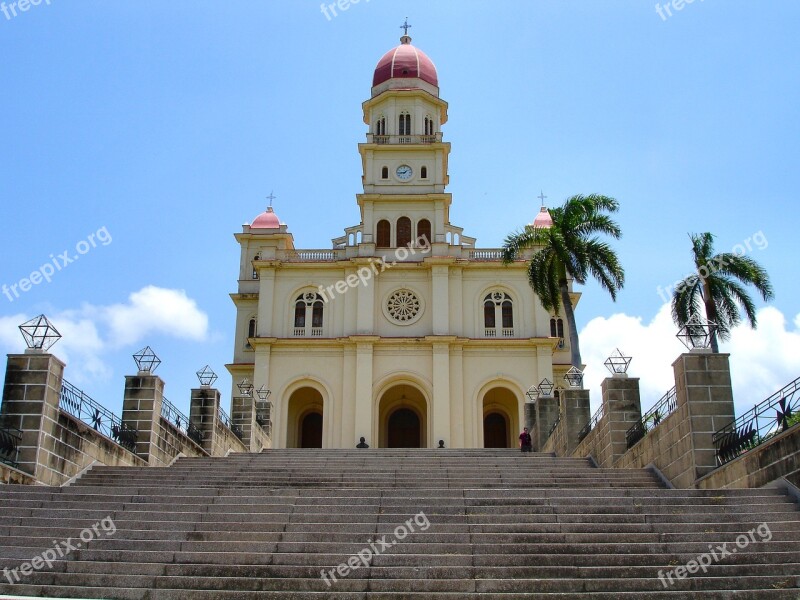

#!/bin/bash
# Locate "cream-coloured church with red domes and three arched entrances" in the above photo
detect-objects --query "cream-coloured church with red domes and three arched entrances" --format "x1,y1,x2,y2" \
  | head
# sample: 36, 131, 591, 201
228, 35, 579, 448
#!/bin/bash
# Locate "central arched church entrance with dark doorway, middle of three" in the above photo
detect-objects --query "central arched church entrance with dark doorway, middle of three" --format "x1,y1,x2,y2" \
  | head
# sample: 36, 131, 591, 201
378, 384, 428, 448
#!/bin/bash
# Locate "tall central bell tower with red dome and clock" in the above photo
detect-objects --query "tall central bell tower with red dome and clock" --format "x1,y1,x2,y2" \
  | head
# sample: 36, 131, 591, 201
358, 29, 451, 247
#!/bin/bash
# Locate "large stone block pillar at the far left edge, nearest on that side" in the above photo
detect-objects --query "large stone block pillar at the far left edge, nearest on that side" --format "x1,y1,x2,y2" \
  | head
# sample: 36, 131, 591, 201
2, 350, 65, 485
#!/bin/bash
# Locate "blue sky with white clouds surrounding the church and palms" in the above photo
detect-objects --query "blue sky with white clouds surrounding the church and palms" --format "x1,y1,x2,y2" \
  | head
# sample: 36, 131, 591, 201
0, 0, 800, 422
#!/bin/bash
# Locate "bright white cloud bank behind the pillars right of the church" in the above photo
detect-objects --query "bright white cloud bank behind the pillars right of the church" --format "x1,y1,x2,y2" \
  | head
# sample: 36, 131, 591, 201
580, 304, 800, 415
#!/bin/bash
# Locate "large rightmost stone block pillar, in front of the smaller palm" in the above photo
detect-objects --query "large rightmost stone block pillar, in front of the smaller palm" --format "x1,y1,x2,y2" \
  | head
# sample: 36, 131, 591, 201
672, 350, 735, 488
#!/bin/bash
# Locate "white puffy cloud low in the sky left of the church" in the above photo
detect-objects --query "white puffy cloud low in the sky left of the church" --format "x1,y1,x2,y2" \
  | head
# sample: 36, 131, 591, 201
0, 286, 208, 385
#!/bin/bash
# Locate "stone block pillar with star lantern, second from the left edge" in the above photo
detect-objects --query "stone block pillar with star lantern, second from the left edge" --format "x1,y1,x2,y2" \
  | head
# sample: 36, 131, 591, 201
122, 371, 164, 466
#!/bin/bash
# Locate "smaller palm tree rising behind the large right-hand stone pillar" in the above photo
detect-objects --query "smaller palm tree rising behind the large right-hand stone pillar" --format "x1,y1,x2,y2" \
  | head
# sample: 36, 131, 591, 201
672, 232, 774, 352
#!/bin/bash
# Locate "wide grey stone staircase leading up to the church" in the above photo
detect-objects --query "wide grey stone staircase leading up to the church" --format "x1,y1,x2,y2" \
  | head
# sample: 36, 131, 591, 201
0, 449, 800, 600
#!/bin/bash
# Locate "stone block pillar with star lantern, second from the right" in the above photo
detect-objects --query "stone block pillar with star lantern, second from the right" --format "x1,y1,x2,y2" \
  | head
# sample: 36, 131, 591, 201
594, 374, 642, 468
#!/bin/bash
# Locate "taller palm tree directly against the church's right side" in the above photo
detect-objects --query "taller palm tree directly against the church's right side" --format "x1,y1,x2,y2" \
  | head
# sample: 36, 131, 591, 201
503, 194, 625, 369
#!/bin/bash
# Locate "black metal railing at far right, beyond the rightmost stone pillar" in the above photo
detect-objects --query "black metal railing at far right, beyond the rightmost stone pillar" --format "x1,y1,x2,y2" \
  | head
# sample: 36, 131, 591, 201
713, 377, 800, 466
